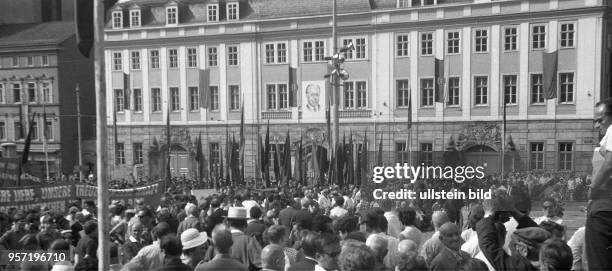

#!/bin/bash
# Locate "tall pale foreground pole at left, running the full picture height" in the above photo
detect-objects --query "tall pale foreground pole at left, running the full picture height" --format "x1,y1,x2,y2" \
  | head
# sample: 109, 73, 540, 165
94, 0, 110, 270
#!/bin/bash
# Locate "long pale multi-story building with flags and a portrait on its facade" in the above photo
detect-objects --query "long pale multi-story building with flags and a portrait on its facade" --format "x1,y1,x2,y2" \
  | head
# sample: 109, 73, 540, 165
105, 0, 612, 183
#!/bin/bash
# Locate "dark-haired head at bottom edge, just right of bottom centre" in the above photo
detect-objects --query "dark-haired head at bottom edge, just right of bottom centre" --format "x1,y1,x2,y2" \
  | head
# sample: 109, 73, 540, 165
338, 243, 376, 271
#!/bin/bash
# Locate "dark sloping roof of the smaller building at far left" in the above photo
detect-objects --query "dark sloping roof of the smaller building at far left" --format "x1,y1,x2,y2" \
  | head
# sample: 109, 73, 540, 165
0, 21, 75, 46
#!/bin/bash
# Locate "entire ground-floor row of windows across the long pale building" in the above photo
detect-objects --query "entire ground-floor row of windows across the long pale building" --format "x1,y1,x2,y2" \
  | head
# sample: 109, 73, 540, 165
115, 141, 574, 170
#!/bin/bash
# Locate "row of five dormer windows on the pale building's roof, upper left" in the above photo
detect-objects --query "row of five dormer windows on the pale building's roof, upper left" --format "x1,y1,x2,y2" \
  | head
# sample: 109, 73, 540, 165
112, 2, 240, 29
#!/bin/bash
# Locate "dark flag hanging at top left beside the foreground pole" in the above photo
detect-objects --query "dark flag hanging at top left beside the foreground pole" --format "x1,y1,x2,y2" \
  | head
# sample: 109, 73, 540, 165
74, 0, 118, 58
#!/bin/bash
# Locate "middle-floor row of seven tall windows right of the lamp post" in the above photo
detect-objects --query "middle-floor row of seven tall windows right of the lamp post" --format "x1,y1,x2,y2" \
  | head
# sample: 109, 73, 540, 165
396, 72, 575, 107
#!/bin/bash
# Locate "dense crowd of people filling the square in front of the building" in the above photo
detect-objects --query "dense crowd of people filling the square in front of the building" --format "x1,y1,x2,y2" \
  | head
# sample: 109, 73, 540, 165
0, 171, 588, 271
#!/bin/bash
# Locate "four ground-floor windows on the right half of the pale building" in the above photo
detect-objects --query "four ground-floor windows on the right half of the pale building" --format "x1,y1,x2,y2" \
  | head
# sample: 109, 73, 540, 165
395, 142, 574, 170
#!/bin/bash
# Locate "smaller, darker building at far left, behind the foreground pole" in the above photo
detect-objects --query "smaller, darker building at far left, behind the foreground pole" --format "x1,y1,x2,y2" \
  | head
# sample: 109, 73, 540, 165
0, 21, 95, 181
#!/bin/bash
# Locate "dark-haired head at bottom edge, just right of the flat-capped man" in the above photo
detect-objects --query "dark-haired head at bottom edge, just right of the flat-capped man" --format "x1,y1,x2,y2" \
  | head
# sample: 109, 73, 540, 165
539, 239, 573, 271
